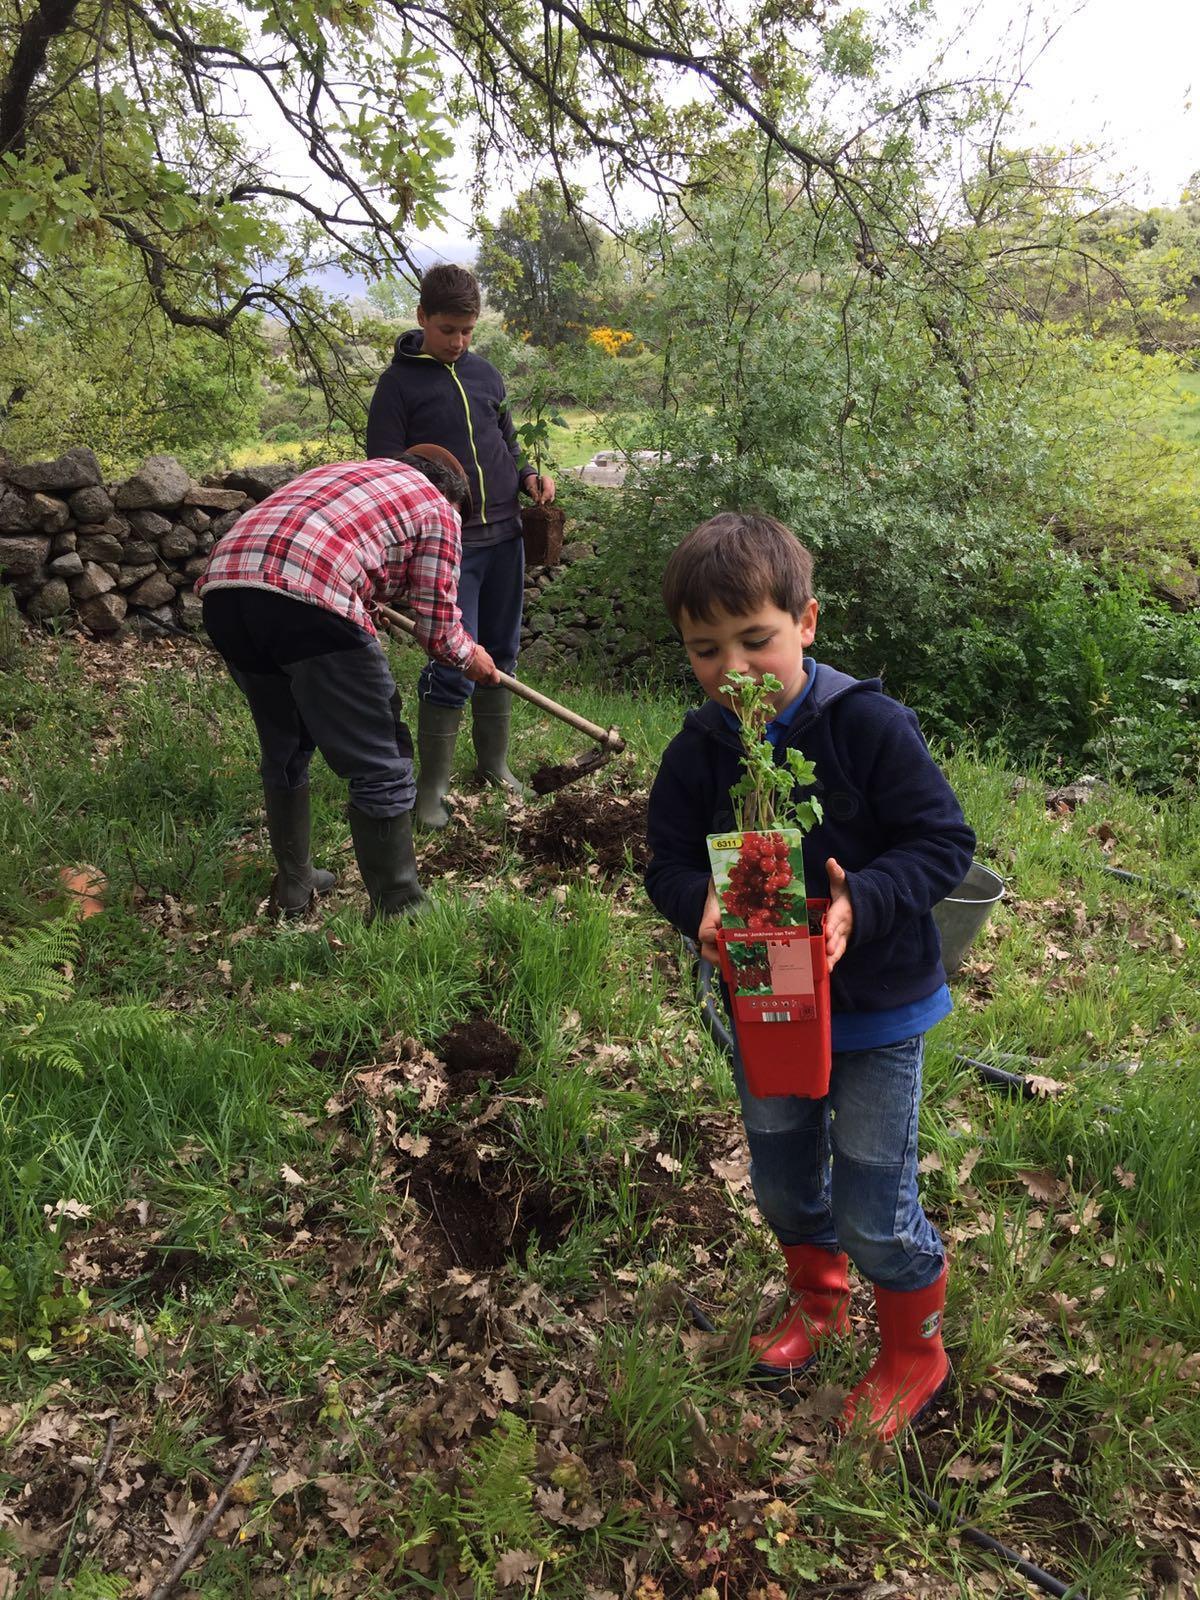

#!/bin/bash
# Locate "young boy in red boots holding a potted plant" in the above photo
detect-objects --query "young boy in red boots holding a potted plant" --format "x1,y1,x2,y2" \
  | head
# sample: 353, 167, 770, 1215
646, 512, 974, 1438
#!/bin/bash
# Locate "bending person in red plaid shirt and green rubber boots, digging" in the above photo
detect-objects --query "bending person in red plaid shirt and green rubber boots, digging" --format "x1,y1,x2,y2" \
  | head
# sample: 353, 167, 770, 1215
195, 457, 498, 917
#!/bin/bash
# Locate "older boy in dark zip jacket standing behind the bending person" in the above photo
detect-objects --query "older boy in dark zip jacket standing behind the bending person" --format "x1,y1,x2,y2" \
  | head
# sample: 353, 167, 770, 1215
366, 266, 554, 827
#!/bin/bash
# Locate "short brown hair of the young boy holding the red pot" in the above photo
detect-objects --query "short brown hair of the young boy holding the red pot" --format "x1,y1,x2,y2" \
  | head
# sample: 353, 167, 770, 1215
662, 510, 813, 627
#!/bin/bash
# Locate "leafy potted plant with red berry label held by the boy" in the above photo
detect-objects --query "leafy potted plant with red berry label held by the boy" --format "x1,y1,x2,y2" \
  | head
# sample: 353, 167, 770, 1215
709, 672, 832, 1098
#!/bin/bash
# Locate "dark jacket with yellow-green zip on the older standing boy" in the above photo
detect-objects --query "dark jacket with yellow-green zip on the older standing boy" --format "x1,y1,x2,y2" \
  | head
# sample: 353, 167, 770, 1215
366, 328, 533, 544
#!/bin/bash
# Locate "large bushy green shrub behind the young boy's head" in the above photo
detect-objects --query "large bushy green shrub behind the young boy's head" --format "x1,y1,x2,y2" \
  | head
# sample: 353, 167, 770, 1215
572, 131, 1200, 787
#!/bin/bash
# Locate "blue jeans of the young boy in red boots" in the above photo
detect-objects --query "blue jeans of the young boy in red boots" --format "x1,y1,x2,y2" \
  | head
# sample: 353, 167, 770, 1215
733, 1034, 944, 1291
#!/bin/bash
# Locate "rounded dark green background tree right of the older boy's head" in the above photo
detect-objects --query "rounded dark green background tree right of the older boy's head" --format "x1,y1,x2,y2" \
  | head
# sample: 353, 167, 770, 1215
475, 178, 600, 346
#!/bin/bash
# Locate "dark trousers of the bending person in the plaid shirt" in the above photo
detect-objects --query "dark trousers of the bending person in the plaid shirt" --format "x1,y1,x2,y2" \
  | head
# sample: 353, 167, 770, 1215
203, 589, 416, 818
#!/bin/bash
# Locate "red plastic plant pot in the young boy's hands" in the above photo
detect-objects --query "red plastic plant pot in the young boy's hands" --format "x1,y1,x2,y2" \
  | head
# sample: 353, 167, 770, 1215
717, 901, 832, 1099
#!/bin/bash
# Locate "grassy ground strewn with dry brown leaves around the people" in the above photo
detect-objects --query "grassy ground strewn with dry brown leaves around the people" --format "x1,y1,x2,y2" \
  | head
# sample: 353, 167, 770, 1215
0, 640, 1200, 1600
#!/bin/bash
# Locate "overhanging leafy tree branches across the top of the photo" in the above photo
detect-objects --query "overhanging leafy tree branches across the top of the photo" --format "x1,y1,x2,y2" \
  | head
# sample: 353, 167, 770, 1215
0, 0, 979, 451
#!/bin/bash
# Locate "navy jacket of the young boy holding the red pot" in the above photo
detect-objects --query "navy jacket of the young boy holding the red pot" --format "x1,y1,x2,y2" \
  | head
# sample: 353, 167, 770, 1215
646, 656, 974, 1013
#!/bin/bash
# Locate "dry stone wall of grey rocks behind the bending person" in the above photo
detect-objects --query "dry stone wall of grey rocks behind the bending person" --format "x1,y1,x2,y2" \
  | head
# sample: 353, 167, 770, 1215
0, 448, 643, 669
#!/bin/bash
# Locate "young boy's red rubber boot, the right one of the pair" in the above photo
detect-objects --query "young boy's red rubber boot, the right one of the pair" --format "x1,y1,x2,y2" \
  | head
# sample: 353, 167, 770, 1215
842, 1267, 950, 1440
